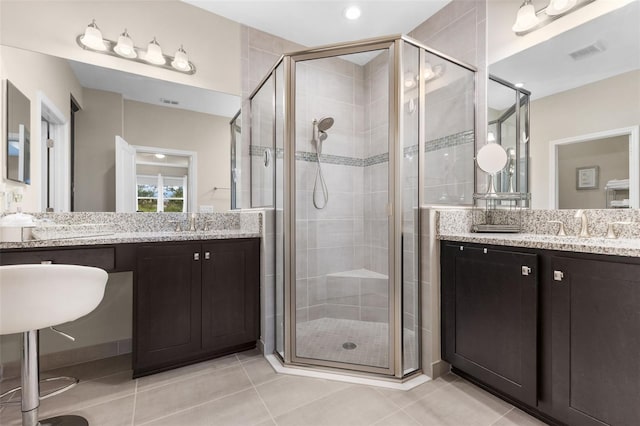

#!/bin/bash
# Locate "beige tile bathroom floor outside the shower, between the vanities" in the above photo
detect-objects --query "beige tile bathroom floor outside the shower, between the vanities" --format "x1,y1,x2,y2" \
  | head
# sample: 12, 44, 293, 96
0, 351, 544, 426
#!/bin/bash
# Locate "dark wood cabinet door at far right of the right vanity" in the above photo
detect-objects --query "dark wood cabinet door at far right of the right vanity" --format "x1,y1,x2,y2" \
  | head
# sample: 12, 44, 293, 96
549, 257, 640, 425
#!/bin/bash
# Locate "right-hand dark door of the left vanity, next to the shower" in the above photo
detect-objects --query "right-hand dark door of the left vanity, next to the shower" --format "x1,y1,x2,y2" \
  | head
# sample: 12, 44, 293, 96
202, 240, 260, 350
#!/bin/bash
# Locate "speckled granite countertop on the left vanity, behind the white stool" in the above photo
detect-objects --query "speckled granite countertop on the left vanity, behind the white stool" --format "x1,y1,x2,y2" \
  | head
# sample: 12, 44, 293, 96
0, 229, 260, 250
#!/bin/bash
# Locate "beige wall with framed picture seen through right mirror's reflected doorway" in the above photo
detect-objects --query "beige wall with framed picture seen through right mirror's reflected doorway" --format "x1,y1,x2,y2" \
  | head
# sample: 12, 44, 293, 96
558, 136, 629, 209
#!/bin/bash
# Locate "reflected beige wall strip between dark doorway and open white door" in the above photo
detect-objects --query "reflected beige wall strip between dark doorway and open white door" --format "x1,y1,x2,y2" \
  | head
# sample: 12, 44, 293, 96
74, 89, 126, 212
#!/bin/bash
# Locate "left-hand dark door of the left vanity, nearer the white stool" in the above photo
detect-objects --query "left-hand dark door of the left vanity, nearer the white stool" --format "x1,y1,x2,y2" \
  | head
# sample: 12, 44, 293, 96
133, 244, 202, 374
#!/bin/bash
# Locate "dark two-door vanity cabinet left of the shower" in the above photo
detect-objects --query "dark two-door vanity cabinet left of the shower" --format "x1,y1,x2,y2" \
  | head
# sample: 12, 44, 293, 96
133, 239, 260, 377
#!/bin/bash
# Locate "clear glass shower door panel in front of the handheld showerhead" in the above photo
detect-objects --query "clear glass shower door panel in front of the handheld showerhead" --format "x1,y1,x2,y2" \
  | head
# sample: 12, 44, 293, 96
292, 49, 394, 374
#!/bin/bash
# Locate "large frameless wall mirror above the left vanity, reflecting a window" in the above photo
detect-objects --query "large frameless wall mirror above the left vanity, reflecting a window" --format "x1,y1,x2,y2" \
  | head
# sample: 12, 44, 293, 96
0, 46, 240, 212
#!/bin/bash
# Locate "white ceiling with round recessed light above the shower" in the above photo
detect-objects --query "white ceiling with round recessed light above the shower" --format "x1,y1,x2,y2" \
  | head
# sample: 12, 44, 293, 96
182, 0, 451, 47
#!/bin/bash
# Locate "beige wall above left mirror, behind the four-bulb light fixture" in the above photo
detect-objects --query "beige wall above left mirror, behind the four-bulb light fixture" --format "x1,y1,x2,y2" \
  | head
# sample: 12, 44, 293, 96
0, 0, 241, 95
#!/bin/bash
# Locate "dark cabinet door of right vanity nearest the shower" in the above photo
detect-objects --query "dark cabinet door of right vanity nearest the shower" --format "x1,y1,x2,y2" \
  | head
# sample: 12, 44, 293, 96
441, 243, 538, 407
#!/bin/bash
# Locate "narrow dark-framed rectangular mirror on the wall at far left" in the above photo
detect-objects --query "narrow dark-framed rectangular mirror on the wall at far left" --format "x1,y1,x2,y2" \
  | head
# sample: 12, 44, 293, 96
5, 80, 31, 184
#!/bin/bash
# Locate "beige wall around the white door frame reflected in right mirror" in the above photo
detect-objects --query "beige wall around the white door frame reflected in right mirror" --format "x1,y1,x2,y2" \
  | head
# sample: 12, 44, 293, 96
530, 71, 640, 209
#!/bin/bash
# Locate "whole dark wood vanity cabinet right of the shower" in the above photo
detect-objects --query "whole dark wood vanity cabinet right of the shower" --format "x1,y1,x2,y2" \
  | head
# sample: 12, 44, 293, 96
441, 241, 640, 426
